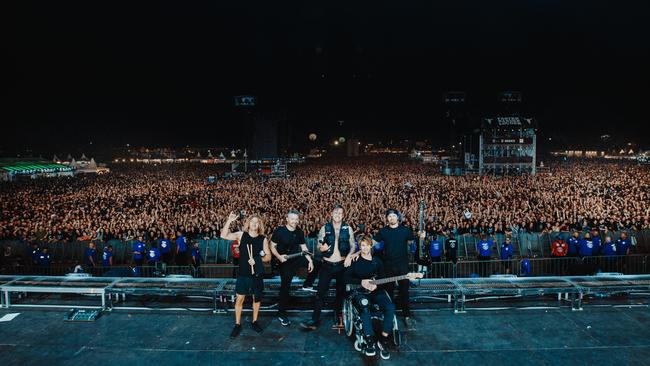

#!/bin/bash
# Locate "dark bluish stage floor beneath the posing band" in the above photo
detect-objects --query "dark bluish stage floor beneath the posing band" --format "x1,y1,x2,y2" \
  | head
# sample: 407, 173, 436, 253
0, 306, 650, 366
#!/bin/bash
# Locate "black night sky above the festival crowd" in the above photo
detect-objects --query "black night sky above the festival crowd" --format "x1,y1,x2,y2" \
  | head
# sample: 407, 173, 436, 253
8, 0, 650, 153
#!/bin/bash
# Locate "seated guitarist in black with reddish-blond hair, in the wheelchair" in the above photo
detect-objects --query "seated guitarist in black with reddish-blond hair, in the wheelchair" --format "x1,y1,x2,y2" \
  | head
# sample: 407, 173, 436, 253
345, 235, 395, 359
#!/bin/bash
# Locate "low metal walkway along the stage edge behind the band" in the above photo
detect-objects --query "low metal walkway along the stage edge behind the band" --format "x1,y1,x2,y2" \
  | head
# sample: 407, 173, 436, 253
0, 273, 650, 313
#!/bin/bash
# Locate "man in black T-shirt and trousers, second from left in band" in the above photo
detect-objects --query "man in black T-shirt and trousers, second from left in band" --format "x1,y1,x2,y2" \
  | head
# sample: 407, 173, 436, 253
270, 210, 314, 327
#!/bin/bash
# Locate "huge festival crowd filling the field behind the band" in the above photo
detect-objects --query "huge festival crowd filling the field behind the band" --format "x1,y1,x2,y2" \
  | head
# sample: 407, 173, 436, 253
0, 158, 650, 249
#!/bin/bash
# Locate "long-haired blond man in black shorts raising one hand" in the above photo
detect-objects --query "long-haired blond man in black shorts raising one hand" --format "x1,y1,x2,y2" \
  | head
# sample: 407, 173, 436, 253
221, 212, 271, 338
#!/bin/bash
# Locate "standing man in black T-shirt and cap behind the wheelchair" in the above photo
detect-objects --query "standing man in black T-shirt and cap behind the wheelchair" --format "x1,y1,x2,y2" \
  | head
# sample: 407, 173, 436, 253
373, 208, 426, 328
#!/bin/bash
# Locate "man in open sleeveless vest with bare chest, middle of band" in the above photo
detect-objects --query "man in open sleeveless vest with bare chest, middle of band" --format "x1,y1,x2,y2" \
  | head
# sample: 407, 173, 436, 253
300, 205, 357, 330
